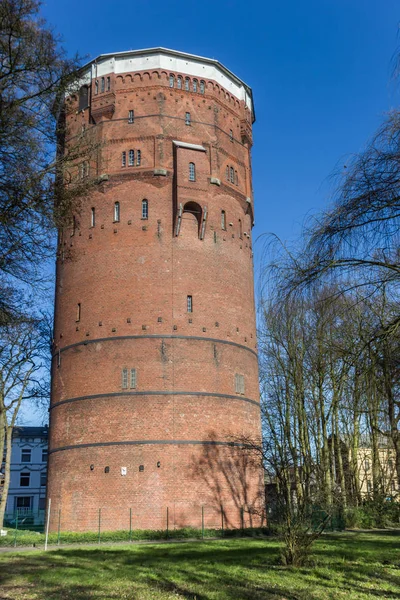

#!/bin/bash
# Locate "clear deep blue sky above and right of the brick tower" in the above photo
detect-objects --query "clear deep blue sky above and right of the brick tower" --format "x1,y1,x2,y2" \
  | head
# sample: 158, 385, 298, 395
42, 0, 400, 246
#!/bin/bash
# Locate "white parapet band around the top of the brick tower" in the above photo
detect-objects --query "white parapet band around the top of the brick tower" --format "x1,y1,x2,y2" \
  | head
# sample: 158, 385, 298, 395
76, 48, 255, 121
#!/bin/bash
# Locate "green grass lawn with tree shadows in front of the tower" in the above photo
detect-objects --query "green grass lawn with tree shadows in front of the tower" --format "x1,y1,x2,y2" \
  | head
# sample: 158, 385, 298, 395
0, 531, 400, 600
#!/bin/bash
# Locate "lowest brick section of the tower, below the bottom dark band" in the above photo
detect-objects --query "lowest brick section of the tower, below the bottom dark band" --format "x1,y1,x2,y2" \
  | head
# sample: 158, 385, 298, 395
48, 444, 266, 532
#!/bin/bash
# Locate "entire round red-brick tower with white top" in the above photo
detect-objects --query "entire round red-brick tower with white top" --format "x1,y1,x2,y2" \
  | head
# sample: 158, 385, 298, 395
48, 49, 263, 531
